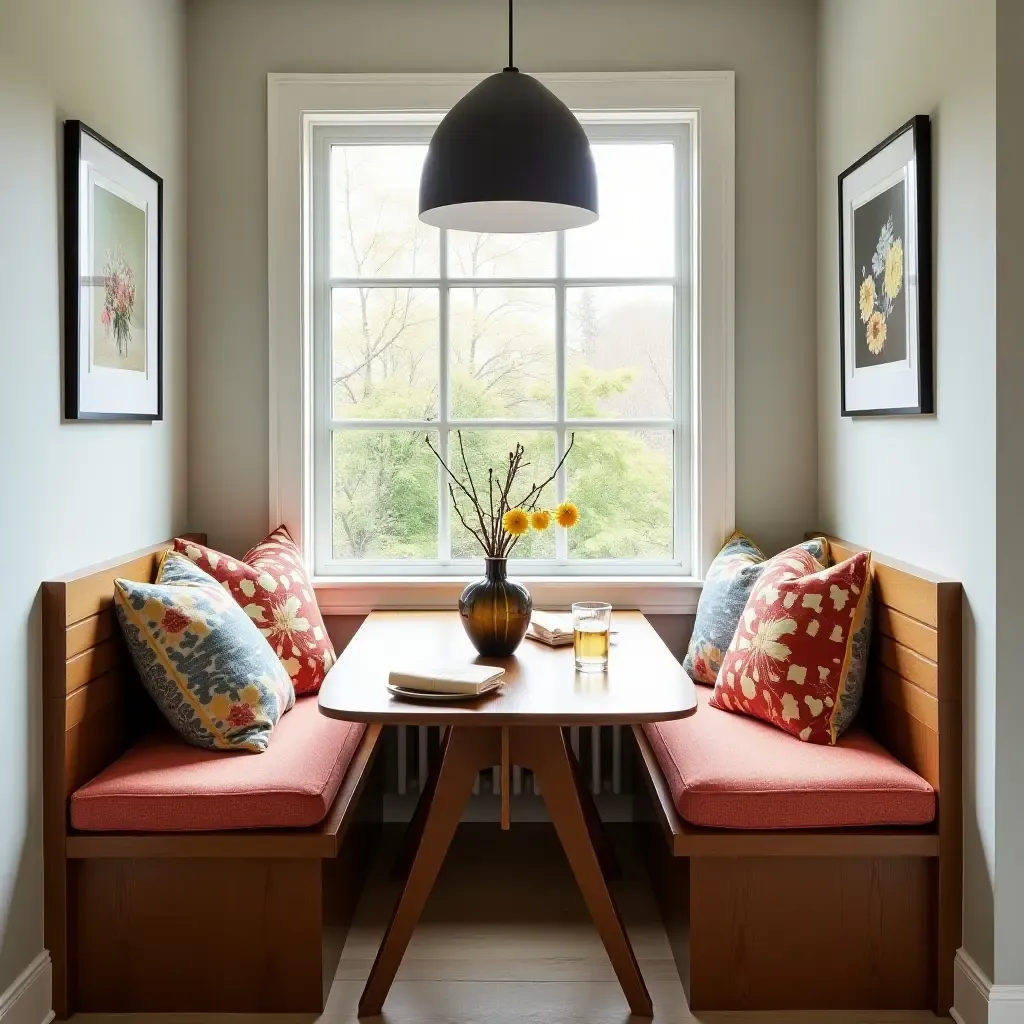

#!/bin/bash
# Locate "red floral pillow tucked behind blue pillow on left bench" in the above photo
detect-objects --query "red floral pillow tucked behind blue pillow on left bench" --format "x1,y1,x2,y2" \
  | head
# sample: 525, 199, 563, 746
174, 526, 336, 695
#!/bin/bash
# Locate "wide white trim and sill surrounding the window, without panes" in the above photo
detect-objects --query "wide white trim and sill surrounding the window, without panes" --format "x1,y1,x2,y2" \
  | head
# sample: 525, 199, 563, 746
267, 72, 735, 614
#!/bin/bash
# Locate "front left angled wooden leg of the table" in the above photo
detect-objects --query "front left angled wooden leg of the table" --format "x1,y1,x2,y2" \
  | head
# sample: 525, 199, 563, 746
358, 726, 501, 1017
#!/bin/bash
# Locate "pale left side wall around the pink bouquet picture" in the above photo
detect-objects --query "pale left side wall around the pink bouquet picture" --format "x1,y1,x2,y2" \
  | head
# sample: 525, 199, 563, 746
0, 0, 186, 991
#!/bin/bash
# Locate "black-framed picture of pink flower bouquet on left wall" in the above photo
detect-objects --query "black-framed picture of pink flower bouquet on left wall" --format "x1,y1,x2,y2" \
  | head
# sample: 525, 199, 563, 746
63, 121, 164, 420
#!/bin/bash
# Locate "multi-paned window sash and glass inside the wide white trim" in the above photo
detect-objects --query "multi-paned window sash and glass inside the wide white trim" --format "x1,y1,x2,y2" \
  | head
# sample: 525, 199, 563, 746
311, 123, 689, 574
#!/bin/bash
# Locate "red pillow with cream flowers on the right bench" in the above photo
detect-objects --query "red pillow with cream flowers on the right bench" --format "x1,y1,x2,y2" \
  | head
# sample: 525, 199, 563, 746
711, 548, 871, 743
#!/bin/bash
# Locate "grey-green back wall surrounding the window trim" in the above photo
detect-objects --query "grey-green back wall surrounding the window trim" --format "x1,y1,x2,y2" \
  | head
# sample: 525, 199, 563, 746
188, 0, 816, 550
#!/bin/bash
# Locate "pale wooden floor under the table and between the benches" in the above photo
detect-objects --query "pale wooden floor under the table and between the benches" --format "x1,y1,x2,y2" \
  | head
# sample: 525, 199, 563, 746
73, 824, 950, 1024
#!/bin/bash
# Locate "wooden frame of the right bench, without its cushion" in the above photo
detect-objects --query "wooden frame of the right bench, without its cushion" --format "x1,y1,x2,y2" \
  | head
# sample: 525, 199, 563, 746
634, 540, 962, 1016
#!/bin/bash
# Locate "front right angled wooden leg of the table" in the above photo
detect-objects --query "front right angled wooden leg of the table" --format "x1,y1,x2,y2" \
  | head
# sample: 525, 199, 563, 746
512, 727, 654, 1017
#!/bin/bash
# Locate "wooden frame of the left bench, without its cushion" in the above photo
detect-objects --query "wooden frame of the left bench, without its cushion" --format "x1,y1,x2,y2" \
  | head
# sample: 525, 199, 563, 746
42, 535, 382, 1019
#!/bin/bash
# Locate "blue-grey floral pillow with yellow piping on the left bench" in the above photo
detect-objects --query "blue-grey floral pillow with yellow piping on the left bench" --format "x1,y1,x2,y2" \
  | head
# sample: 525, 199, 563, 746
114, 551, 295, 753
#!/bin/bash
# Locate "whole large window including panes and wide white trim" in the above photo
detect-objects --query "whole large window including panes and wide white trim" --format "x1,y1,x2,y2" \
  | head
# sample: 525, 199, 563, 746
269, 75, 732, 607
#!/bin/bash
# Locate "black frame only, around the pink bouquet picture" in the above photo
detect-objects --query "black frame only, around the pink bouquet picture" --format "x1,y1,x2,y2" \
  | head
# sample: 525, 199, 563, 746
63, 120, 164, 422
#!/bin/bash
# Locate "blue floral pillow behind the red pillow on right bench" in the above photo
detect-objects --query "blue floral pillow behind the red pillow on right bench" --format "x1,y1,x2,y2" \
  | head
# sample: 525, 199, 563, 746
683, 529, 828, 686
